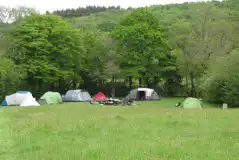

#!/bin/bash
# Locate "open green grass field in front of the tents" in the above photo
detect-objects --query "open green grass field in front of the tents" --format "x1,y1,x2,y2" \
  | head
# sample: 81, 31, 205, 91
0, 99, 239, 160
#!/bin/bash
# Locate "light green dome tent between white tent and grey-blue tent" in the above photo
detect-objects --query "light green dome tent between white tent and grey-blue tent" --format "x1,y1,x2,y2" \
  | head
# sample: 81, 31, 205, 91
39, 92, 63, 105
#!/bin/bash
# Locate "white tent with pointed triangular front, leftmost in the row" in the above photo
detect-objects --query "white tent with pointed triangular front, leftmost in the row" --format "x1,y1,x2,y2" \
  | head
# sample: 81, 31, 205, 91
5, 91, 39, 106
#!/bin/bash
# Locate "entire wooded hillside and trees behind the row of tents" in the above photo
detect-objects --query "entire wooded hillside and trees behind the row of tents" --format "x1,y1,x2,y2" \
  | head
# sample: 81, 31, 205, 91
0, 0, 239, 106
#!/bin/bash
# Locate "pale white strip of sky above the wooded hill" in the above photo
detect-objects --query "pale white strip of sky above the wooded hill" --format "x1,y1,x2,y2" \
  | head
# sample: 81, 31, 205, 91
1, 0, 211, 13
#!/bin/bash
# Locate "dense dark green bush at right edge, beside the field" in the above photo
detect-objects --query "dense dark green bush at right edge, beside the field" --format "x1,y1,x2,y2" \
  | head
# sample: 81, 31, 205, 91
203, 50, 239, 107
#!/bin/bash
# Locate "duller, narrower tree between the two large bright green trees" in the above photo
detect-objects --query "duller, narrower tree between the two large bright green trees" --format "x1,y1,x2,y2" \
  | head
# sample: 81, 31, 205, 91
80, 29, 119, 96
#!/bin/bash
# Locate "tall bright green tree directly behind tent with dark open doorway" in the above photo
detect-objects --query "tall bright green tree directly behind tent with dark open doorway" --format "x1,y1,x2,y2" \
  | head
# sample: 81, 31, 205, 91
112, 8, 168, 86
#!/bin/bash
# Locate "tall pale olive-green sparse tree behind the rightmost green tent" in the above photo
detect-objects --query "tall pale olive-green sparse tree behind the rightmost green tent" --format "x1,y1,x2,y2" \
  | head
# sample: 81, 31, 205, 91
169, 4, 233, 96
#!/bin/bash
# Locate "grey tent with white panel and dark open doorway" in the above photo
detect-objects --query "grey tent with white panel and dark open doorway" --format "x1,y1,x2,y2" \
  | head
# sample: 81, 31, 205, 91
127, 88, 160, 100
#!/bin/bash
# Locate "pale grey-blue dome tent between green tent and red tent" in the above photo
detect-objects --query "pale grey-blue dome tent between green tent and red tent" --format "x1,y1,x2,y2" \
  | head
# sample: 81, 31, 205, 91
64, 89, 91, 102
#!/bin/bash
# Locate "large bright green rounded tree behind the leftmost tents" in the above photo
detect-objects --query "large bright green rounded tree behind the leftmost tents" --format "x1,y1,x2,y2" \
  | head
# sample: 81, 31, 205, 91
9, 14, 84, 94
